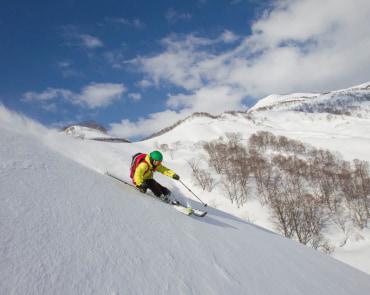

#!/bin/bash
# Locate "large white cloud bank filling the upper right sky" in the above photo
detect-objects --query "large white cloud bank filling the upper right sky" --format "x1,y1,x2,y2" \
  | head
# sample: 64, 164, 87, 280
111, 0, 370, 139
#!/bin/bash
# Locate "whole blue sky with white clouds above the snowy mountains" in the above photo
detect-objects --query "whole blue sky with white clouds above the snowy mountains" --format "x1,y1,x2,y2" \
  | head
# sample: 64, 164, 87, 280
0, 0, 370, 138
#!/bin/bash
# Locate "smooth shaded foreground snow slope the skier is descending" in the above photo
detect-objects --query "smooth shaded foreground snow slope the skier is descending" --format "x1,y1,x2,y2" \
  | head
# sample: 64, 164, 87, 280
0, 109, 370, 295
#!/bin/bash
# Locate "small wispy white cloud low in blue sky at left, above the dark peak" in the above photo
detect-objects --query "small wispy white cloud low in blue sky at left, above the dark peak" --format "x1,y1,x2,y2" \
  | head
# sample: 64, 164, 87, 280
23, 83, 126, 110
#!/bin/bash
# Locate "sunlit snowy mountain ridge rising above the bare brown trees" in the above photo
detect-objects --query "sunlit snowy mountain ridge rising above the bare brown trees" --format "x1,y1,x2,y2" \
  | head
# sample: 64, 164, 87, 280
138, 82, 370, 165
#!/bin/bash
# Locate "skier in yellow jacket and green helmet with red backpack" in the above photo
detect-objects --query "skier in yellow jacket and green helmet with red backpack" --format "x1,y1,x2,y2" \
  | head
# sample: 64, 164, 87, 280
130, 151, 180, 202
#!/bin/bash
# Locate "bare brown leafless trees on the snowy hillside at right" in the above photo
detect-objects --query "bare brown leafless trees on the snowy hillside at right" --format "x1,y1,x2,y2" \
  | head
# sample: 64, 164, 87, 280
189, 131, 370, 252
